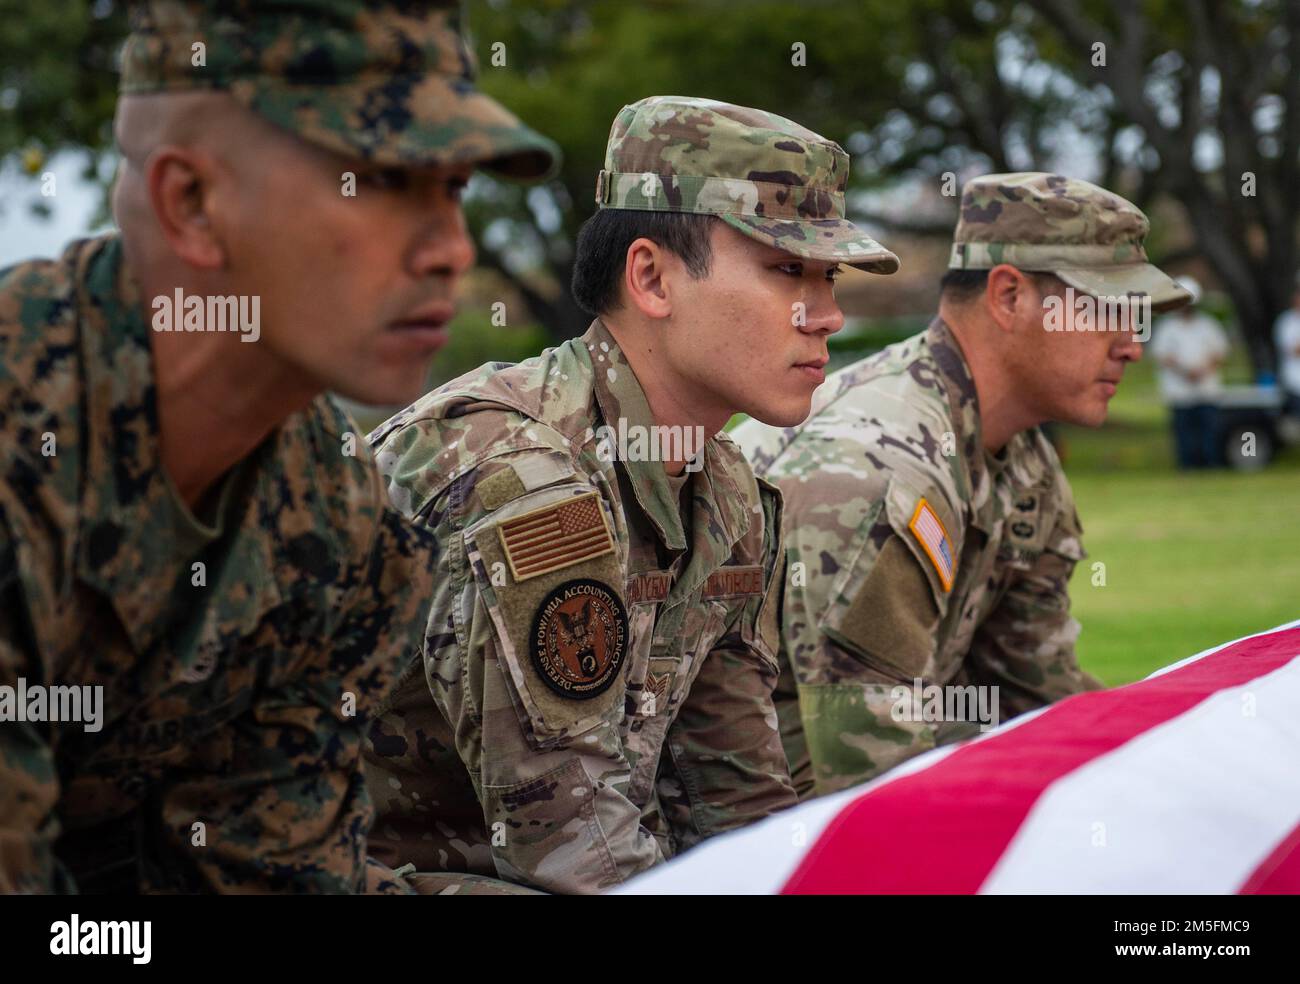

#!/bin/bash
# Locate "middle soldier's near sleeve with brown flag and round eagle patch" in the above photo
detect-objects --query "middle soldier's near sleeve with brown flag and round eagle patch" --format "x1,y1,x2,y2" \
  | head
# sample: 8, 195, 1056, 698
425, 454, 663, 893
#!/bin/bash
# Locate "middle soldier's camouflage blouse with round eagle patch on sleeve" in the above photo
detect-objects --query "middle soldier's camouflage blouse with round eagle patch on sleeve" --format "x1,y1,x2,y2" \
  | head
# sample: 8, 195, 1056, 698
367, 321, 796, 892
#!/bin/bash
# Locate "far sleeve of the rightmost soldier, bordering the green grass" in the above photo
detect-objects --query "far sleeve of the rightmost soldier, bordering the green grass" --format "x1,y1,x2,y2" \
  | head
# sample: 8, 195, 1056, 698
966, 476, 1102, 720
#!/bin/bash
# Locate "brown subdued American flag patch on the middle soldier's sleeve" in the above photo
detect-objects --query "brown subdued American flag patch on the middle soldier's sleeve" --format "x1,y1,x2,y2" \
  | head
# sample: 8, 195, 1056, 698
497, 491, 614, 581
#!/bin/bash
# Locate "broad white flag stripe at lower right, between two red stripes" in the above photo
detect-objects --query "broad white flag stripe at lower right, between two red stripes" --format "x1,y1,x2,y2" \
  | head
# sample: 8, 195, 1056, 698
980, 656, 1300, 894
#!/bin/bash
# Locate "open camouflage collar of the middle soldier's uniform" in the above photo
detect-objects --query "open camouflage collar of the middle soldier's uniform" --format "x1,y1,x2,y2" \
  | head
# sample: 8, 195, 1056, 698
579, 318, 762, 593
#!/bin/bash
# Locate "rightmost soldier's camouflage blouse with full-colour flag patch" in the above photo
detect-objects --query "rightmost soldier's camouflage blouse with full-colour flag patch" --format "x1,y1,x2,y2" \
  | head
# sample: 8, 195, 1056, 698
735, 320, 1100, 797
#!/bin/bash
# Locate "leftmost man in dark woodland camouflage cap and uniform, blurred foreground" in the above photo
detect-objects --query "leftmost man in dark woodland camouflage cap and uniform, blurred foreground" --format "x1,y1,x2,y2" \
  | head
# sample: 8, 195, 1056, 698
0, 0, 553, 892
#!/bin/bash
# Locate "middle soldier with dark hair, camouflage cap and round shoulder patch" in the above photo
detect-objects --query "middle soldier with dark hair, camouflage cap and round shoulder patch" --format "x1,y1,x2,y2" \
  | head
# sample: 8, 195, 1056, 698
367, 96, 897, 892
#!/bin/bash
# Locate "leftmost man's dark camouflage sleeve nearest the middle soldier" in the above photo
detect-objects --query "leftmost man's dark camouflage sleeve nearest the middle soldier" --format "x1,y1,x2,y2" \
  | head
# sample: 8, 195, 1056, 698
163, 510, 430, 893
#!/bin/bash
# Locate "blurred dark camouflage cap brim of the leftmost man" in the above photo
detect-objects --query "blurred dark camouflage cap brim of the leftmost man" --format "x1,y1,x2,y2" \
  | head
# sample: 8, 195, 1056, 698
230, 74, 560, 181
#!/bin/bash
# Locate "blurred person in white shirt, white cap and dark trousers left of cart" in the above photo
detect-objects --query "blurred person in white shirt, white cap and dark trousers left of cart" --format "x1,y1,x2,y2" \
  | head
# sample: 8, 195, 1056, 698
1151, 277, 1229, 468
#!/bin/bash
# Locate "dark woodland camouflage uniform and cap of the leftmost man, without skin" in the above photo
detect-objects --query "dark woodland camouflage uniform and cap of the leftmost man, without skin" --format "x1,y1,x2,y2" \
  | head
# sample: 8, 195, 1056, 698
0, 1, 550, 892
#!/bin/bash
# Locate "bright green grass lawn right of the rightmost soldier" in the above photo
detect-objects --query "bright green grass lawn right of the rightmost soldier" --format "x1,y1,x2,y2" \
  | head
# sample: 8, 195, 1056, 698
1062, 353, 1300, 685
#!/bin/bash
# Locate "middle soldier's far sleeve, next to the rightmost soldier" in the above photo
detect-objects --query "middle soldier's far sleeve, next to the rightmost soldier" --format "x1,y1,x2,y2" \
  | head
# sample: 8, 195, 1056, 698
660, 494, 798, 850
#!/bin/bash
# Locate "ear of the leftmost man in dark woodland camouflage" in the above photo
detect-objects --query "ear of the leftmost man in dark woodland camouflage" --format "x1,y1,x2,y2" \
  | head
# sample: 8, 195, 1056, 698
146, 147, 226, 270
